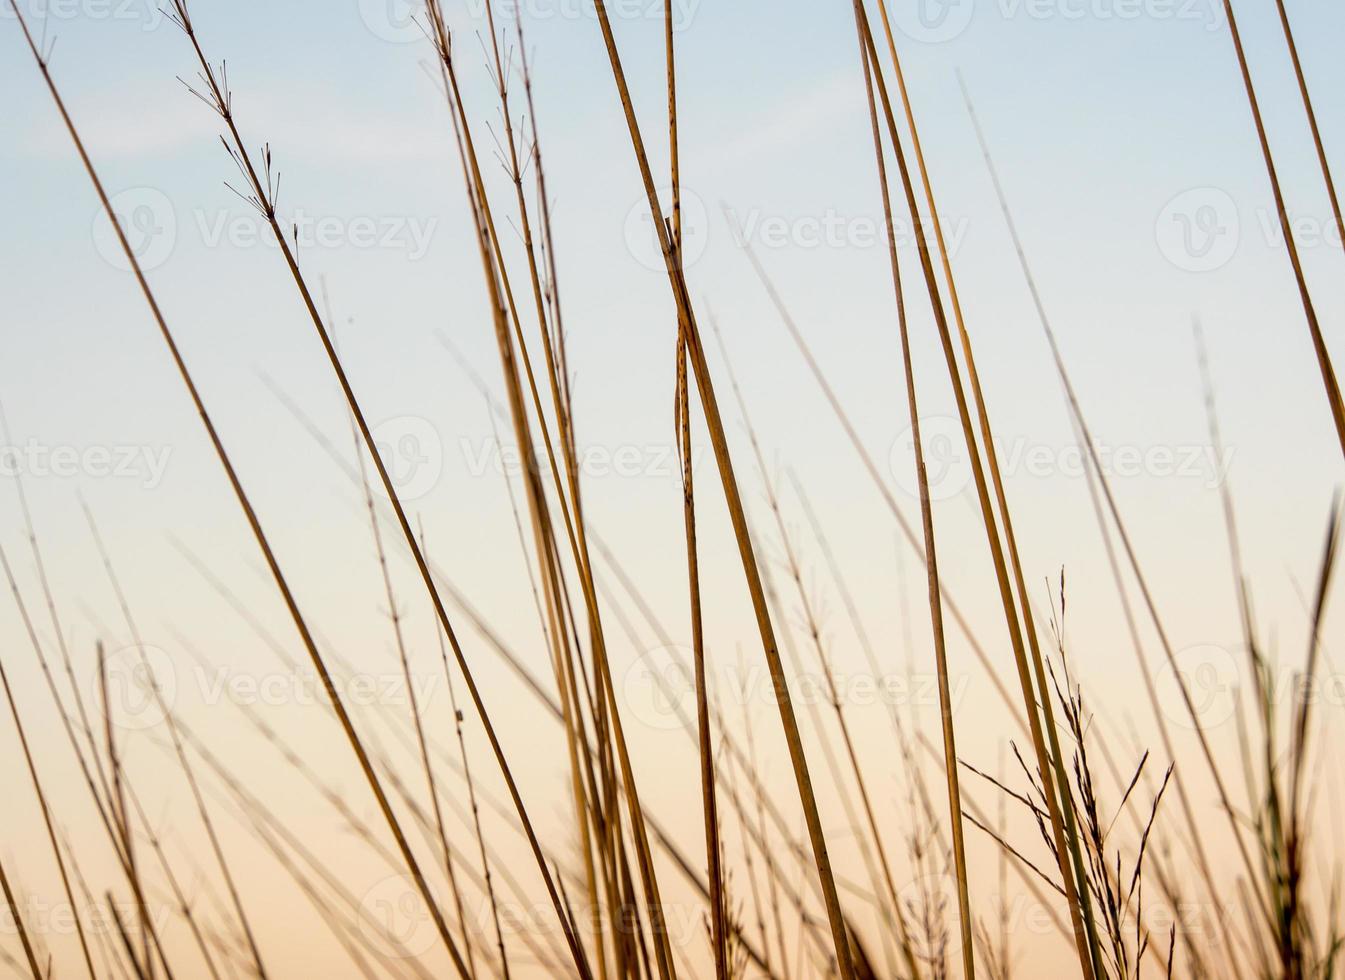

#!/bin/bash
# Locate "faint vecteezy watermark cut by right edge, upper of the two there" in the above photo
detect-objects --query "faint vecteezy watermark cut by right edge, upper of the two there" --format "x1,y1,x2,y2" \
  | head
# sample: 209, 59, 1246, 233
1154, 187, 1341, 272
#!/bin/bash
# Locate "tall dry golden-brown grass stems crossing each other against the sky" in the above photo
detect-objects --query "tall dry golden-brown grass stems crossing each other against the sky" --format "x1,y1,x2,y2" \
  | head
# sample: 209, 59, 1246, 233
0, 0, 1345, 980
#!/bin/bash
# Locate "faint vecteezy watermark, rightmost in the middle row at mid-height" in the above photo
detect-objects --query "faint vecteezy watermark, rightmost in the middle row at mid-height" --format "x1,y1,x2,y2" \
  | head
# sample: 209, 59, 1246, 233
888, 415, 1236, 500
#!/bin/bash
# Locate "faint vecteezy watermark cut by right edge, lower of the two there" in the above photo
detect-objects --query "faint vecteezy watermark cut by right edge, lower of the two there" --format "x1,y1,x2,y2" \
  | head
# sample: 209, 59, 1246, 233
1154, 643, 1345, 730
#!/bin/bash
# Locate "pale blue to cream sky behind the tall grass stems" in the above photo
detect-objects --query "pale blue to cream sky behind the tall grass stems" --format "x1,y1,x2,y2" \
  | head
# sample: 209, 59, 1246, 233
0, 0, 1345, 960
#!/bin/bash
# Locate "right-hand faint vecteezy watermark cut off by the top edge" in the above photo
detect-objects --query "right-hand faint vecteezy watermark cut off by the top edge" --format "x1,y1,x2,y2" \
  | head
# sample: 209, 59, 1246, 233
892, 0, 1223, 44
